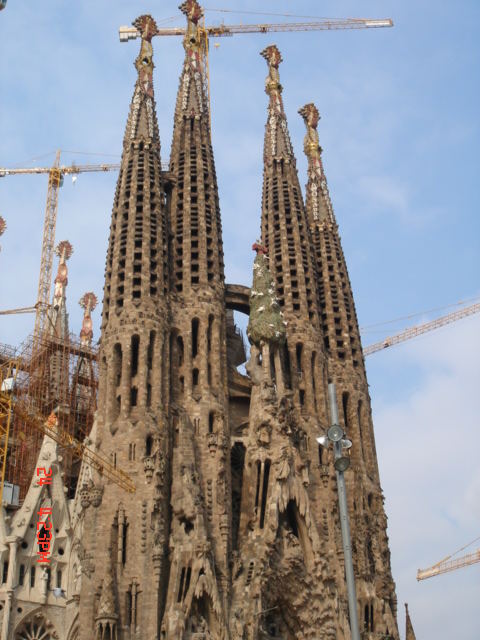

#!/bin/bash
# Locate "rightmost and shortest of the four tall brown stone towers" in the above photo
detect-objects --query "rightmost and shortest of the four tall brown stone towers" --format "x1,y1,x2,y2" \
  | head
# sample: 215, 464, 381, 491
299, 103, 397, 637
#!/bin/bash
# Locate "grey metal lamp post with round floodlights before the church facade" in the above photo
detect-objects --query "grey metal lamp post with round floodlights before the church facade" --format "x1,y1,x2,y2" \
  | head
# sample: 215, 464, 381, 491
317, 382, 360, 640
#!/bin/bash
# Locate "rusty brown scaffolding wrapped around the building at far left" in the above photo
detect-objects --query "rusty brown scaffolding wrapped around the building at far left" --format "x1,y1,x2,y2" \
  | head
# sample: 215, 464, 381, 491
0, 332, 98, 500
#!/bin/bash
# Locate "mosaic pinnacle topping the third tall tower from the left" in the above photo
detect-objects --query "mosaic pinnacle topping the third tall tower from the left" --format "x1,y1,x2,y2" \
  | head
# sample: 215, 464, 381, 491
260, 44, 295, 163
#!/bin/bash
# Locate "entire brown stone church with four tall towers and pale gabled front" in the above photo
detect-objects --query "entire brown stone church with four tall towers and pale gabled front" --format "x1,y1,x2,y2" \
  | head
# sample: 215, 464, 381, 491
0, 0, 404, 640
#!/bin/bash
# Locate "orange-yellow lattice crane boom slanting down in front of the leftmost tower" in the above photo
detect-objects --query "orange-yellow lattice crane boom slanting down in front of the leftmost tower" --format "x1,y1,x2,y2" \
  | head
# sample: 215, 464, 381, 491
0, 360, 135, 504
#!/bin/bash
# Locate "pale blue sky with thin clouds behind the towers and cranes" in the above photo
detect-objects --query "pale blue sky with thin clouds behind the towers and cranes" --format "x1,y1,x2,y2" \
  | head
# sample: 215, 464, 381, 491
0, 0, 480, 640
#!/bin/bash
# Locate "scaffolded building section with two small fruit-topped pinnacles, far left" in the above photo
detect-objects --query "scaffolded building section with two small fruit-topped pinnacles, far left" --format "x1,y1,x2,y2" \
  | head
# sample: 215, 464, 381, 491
0, 241, 98, 502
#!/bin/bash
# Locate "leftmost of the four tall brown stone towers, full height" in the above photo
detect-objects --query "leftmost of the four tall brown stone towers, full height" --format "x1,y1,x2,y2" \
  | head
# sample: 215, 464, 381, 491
78, 15, 170, 640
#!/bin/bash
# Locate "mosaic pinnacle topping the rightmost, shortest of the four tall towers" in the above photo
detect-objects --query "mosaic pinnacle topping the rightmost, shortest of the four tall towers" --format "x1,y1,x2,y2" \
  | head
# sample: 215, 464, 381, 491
298, 102, 336, 224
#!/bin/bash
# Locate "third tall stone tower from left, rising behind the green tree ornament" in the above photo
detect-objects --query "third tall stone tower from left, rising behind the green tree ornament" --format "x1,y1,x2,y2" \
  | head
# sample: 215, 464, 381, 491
261, 45, 324, 420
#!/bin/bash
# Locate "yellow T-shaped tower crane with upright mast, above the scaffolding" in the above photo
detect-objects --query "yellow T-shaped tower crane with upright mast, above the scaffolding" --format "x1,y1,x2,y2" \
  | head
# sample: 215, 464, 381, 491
0, 151, 120, 336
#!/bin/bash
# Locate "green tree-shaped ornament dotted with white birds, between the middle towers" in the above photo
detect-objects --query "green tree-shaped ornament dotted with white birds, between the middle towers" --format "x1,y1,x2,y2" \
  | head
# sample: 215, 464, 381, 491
247, 242, 285, 346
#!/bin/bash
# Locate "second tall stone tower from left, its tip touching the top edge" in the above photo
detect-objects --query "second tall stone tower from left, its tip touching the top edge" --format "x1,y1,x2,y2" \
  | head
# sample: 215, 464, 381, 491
166, 0, 230, 624
